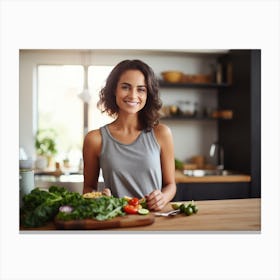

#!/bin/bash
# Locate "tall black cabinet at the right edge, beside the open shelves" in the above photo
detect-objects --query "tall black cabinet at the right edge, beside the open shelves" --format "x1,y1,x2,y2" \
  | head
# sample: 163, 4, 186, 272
218, 50, 261, 197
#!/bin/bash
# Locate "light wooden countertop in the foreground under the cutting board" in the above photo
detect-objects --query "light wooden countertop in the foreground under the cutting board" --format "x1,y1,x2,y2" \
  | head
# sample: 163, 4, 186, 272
21, 198, 261, 233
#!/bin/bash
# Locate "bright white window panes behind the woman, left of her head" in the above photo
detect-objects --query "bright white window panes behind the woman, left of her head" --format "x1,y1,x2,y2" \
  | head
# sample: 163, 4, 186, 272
38, 65, 113, 169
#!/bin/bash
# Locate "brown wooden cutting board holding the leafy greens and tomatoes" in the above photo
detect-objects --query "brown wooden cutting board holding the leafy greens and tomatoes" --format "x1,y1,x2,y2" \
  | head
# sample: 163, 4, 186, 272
54, 213, 155, 230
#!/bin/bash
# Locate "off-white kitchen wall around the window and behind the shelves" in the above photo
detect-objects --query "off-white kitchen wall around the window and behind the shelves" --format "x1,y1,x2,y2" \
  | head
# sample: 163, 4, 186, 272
19, 50, 221, 164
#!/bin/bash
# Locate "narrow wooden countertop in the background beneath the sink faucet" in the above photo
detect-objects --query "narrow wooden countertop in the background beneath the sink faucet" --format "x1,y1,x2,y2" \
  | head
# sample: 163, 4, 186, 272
175, 170, 251, 183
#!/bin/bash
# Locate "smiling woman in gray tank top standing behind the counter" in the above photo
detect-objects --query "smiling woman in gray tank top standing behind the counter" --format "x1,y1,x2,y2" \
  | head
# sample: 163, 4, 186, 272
83, 60, 176, 211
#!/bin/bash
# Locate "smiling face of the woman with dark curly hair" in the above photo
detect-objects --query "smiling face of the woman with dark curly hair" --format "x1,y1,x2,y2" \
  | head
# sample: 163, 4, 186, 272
116, 70, 147, 114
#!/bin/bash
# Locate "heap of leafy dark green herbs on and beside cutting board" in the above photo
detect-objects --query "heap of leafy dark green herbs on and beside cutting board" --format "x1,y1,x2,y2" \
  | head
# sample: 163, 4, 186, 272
20, 186, 127, 227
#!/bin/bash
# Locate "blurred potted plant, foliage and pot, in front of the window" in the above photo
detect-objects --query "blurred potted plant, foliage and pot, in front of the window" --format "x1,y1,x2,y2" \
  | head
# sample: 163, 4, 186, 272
35, 129, 57, 169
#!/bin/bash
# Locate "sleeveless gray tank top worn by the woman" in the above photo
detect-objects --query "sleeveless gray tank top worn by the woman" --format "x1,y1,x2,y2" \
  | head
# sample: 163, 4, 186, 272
100, 125, 162, 198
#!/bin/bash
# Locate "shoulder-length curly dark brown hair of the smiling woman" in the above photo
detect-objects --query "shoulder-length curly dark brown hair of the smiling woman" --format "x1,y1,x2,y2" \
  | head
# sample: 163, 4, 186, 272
97, 59, 162, 131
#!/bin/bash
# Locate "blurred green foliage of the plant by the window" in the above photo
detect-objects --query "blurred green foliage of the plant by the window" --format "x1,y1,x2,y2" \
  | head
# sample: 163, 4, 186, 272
35, 129, 57, 157
